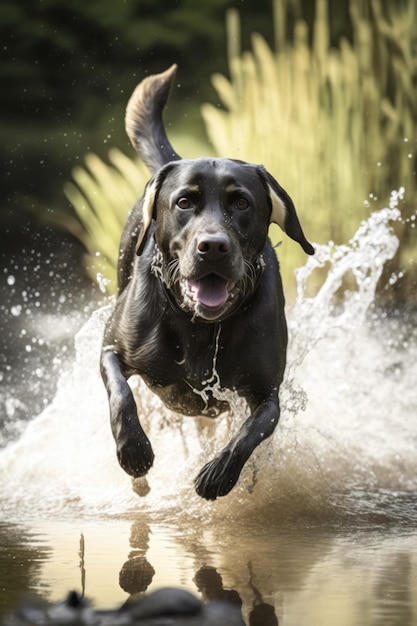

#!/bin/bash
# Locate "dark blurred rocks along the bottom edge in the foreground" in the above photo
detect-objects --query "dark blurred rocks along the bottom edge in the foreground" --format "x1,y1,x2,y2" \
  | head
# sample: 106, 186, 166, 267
3, 587, 245, 626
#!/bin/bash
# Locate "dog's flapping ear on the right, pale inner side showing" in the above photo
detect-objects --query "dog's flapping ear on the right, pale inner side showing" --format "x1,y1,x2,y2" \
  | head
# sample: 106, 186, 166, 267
263, 170, 314, 254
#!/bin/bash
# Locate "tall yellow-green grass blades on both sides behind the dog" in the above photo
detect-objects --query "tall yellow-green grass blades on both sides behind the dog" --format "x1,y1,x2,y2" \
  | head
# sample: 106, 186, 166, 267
57, 0, 417, 292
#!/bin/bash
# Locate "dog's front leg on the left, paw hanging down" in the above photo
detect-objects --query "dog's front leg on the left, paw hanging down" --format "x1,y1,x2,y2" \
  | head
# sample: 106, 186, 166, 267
100, 350, 154, 478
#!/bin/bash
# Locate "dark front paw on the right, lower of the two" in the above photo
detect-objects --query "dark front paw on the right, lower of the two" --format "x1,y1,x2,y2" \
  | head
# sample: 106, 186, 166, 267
194, 451, 243, 500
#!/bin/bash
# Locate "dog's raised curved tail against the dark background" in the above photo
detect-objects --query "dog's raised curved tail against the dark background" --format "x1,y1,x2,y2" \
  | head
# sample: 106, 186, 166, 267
125, 64, 181, 174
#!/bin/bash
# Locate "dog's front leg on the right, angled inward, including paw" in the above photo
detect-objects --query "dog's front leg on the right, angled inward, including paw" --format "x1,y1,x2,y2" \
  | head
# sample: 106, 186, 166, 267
194, 397, 280, 500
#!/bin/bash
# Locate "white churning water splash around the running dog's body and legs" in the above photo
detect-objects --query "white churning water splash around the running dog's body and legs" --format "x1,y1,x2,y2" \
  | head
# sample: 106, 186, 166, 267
0, 194, 417, 519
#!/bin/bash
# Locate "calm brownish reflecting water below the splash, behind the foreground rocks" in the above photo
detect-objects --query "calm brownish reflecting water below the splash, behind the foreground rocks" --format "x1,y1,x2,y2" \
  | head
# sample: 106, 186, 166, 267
1, 498, 417, 626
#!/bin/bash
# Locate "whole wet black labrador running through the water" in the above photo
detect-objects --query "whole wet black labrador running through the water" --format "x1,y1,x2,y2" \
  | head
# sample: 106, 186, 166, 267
101, 65, 314, 500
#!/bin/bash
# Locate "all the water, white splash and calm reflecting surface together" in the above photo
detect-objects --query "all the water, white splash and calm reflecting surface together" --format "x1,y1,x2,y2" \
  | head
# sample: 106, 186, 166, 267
0, 196, 417, 626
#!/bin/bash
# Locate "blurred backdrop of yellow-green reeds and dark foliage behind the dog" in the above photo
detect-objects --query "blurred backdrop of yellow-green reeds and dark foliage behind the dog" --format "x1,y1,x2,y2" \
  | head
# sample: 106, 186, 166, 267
0, 0, 417, 303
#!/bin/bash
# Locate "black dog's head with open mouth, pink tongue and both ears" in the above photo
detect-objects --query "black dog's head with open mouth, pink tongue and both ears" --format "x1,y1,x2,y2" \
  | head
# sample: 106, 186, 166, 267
136, 158, 314, 321
